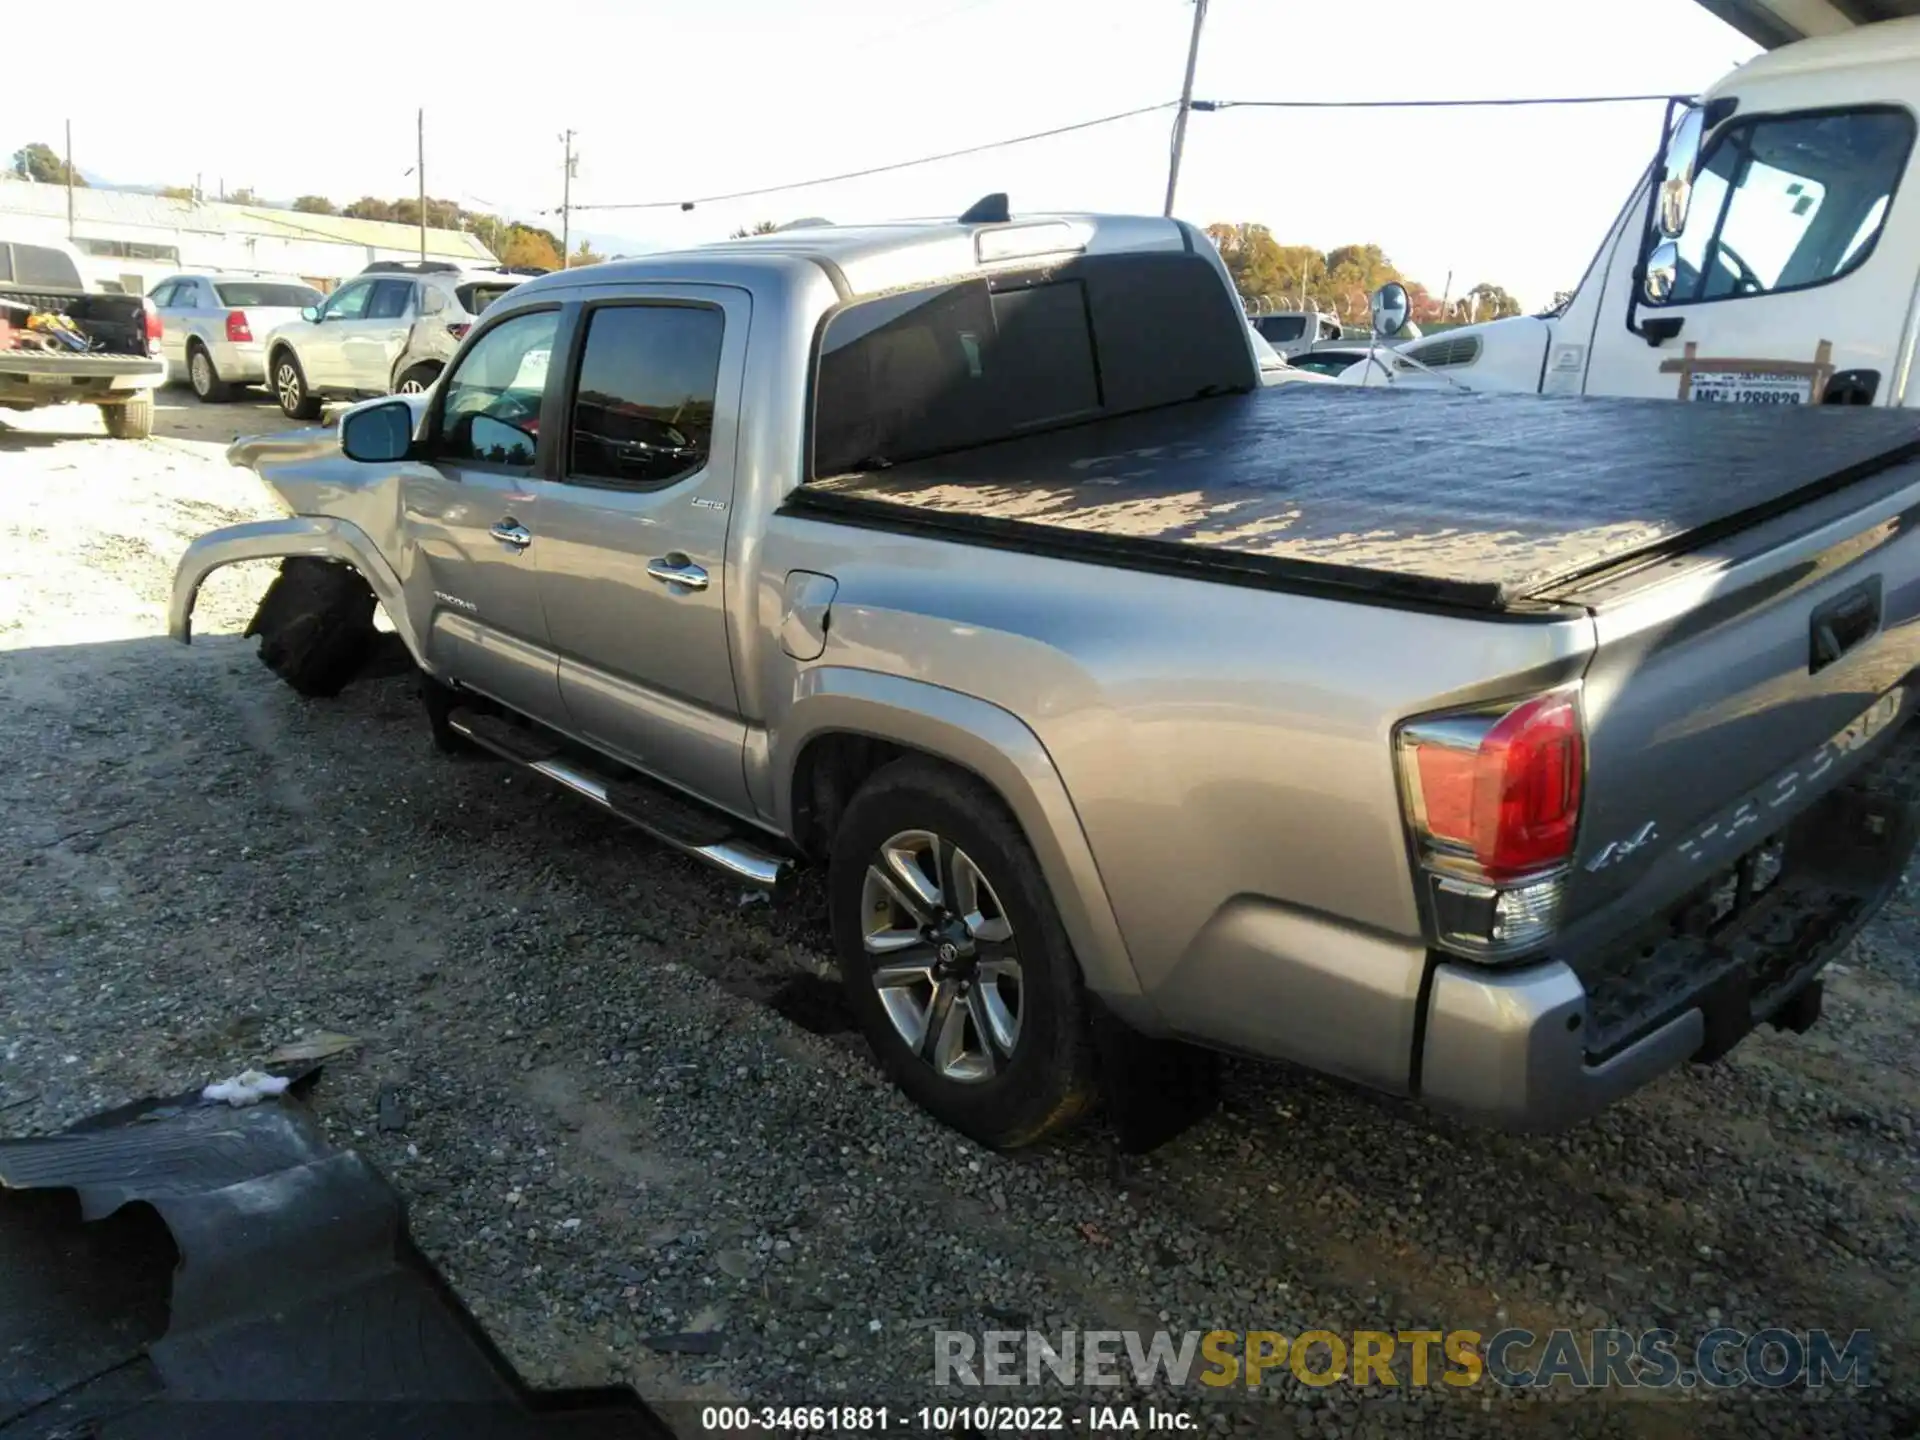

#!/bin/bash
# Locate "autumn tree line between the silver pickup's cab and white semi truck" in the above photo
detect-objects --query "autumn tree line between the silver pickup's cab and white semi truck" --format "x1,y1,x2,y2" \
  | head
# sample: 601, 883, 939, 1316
1206, 223, 1521, 328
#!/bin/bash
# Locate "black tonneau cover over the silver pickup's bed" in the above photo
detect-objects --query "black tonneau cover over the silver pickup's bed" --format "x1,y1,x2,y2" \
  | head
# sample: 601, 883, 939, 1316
787, 382, 1920, 609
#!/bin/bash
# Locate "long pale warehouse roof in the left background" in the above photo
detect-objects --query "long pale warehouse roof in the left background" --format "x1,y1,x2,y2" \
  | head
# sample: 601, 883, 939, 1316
0, 180, 493, 261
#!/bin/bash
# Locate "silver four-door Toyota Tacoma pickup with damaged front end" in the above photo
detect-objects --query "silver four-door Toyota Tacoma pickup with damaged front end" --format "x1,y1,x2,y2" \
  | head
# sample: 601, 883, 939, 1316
171, 205, 1920, 1146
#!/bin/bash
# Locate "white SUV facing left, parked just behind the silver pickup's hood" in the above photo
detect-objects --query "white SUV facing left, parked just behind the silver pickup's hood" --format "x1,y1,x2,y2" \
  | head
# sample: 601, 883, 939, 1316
267, 261, 540, 420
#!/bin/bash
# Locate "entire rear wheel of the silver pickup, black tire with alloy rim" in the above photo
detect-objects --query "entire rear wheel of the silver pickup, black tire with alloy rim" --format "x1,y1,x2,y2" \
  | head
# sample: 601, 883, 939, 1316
828, 758, 1094, 1150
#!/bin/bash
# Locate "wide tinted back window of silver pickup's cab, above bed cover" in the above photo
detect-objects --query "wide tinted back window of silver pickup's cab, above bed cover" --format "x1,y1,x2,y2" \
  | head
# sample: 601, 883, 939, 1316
812, 252, 1260, 476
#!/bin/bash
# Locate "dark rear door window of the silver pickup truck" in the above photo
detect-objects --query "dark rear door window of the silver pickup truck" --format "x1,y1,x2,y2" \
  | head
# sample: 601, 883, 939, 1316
566, 305, 726, 490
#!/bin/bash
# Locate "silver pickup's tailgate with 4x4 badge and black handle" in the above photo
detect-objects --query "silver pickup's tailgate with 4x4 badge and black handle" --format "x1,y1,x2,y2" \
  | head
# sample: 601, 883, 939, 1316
1555, 463, 1920, 1052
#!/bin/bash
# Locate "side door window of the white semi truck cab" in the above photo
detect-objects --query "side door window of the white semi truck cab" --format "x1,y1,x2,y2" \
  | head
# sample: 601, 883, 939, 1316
1667, 108, 1914, 305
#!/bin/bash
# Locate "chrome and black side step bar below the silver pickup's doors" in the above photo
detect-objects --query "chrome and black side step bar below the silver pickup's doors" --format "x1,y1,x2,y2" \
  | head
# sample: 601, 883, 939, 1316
447, 707, 793, 893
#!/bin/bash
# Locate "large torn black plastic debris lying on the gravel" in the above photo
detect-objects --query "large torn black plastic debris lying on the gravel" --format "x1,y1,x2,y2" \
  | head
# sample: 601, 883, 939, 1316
0, 1098, 672, 1440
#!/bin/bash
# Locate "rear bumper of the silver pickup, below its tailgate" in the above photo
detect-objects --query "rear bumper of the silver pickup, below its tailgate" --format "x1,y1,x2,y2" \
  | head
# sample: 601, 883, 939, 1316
1419, 726, 1920, 1131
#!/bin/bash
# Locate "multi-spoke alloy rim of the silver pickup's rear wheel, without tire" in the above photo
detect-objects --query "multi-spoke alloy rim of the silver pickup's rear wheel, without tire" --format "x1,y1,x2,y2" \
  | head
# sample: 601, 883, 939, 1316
860, 829, 1023, 1083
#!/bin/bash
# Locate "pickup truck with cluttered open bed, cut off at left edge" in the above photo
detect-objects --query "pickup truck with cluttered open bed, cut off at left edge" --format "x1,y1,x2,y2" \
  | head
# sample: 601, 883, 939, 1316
0, 238, 167, 440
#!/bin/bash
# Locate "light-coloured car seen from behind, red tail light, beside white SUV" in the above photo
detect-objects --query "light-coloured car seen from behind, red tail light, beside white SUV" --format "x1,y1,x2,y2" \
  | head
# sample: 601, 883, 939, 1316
148, 271, 324, 403
